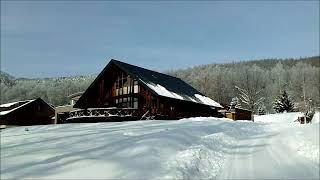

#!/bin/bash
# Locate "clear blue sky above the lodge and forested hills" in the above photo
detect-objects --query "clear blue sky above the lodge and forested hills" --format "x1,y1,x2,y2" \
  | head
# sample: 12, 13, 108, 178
1, 1, 319, 77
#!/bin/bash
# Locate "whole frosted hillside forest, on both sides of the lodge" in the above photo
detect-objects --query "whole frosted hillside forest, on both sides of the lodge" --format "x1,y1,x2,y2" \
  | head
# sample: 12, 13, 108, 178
0, 56, 320, 113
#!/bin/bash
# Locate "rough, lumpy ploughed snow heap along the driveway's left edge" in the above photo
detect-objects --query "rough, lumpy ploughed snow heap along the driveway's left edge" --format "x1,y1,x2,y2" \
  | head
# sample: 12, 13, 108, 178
160, 133, 234, 179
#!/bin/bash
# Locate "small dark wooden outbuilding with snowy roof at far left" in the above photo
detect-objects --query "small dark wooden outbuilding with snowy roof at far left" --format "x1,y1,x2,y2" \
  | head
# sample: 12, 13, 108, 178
0, 98, 54, 126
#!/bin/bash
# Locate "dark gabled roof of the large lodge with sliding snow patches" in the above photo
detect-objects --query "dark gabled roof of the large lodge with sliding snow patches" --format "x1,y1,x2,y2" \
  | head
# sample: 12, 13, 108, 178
75, 59, 222, 108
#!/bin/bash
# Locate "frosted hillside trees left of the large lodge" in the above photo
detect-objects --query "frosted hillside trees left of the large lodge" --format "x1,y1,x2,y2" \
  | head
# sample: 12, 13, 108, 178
1, 72, 95, 106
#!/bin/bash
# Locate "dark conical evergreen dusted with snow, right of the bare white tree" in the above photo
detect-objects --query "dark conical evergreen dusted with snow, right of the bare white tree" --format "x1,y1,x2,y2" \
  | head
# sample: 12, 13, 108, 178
273, 90, 293, 113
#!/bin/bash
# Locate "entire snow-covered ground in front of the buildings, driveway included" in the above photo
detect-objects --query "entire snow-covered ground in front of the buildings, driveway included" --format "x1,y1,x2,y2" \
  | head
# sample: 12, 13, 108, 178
1, 113, 319, 179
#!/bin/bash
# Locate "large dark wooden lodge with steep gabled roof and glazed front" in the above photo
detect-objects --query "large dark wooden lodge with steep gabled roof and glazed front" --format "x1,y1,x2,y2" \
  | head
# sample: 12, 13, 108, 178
67, 59, 222, 122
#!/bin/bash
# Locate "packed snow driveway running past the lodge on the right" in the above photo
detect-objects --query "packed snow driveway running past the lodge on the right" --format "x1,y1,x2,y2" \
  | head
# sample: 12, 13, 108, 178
219, 113, 319, 179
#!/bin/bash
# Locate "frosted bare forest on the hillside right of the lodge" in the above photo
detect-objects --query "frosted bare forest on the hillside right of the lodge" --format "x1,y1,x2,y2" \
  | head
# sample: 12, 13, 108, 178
168, 57, 320, 113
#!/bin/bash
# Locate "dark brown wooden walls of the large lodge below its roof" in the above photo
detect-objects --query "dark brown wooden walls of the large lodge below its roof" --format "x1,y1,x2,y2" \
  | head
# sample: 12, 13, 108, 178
74, 64, 217, 119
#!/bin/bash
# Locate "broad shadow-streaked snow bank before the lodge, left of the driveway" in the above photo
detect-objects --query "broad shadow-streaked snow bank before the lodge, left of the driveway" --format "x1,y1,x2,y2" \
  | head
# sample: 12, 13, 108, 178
1, 118, 250, 179
